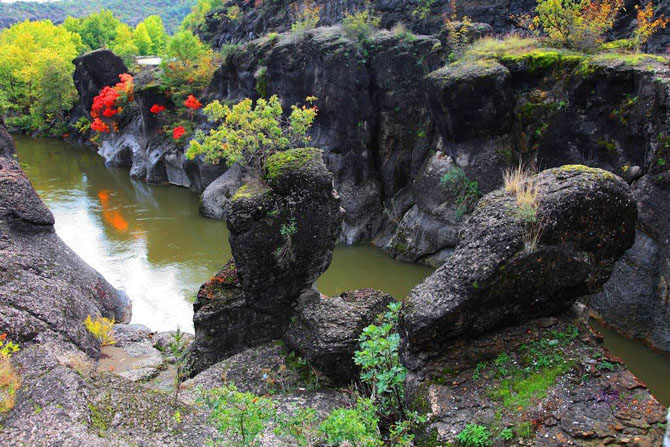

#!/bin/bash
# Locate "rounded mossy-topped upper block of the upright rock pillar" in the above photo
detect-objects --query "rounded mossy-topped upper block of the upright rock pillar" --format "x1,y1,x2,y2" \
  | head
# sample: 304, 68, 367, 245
226, 148, 343, 313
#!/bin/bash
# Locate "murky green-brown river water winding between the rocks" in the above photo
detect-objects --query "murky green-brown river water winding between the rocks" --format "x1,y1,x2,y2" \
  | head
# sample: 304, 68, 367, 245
15, 136, 670, 405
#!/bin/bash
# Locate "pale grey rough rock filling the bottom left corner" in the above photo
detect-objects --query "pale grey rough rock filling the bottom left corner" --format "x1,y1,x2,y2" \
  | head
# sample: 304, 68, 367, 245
0, 342, 218, 447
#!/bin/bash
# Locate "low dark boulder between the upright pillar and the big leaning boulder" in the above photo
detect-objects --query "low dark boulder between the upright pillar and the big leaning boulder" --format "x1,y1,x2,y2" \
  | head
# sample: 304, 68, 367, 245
285, 289, 393, 384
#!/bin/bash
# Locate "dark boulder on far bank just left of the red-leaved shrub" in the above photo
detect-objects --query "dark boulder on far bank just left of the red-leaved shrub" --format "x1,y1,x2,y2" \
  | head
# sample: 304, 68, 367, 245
71, 48, 128, 122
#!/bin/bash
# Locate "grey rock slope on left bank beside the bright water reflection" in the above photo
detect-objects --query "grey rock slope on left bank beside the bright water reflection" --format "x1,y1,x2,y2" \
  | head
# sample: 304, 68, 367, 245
0, 136, 131, 356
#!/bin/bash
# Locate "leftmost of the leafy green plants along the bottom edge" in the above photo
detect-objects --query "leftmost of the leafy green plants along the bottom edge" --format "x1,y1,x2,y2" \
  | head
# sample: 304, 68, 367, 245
200, 385, 277, 447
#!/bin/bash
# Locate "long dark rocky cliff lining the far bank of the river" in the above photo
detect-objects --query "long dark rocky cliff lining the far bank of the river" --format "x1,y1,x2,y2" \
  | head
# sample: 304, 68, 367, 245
69, 13, 670, 350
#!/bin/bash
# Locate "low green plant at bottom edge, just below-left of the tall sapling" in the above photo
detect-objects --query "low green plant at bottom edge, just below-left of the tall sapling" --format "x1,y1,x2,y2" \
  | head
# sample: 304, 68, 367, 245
319, 398, 384, 447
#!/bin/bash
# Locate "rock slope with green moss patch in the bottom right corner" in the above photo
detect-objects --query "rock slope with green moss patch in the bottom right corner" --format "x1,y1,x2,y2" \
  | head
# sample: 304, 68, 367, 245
406, 306, 665, 447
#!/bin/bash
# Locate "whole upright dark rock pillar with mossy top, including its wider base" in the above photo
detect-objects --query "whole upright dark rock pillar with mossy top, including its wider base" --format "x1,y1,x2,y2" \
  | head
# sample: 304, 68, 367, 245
189, 148, 342, 373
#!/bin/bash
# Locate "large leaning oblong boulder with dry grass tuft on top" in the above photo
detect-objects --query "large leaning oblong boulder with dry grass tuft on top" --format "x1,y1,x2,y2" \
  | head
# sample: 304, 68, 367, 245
400, 166, 637, 364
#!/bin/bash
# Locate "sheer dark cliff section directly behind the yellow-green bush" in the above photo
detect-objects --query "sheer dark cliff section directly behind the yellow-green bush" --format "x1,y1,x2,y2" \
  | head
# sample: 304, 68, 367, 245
210, 28, 444, 243
